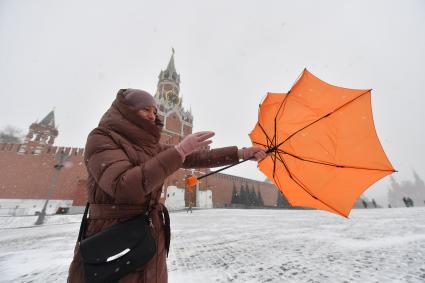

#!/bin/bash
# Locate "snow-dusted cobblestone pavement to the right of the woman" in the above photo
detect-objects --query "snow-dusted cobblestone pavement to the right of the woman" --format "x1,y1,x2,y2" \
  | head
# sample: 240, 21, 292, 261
169, 208, 425, 282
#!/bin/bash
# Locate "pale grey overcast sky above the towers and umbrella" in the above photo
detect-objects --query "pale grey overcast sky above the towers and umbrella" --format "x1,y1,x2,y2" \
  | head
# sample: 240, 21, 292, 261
0, 0, 425, 204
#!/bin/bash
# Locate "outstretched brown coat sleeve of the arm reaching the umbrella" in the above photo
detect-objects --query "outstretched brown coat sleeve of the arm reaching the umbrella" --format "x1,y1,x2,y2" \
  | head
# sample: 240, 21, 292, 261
159, 145, 239, 168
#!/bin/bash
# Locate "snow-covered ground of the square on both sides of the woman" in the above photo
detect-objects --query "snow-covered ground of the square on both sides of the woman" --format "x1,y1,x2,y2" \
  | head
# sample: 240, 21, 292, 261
0, 207, 425, 283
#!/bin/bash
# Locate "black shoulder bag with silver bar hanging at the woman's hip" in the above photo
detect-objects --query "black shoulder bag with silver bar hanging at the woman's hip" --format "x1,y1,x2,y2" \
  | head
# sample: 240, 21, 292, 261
78, 203, 156, 283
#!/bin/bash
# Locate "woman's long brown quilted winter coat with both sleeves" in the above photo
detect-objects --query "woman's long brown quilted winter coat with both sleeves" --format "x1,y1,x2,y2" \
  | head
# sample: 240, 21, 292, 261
68, 95, 238, 283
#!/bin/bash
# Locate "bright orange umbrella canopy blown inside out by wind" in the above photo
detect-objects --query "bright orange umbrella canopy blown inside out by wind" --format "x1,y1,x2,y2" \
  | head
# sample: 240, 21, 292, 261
250, 69, 395, 217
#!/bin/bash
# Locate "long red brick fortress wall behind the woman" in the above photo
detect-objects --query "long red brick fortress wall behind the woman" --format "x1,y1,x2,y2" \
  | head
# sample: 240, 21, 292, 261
0, 144, 277, 207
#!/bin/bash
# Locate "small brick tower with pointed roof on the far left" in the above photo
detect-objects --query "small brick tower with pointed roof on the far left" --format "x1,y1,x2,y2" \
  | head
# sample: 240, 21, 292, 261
18, 110, 58, 155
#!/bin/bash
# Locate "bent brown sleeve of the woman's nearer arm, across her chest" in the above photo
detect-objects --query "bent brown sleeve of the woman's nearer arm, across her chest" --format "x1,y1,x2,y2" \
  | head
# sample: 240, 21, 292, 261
85, 134, 182, 203
